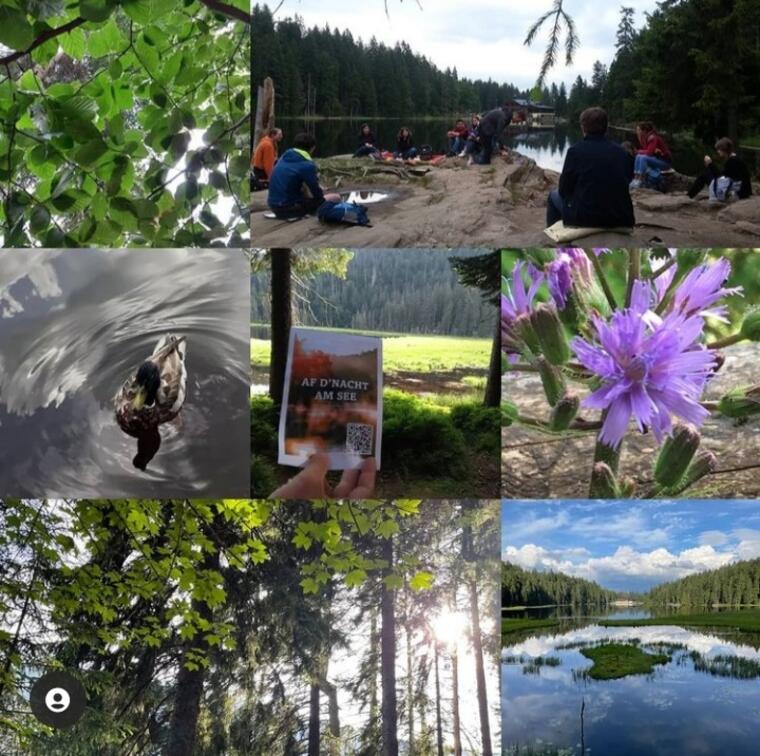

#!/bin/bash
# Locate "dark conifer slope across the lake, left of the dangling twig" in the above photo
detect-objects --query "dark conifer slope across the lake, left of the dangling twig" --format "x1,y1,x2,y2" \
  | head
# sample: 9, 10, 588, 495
252, 5, 548, 118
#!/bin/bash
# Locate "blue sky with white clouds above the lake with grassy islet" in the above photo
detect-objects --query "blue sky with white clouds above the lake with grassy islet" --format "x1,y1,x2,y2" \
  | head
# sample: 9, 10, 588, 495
502, 501, 760, 591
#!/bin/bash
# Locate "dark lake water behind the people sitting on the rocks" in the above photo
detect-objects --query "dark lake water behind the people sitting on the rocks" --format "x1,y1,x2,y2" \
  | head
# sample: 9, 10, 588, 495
279, 118, 748, 175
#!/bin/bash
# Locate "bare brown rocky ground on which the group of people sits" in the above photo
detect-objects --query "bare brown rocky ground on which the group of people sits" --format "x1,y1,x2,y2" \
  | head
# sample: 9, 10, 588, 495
251, 152, 760, 247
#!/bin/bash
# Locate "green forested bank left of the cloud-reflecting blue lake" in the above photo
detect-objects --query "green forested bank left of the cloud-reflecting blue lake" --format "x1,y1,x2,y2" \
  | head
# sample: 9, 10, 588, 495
501, 562, 617, 609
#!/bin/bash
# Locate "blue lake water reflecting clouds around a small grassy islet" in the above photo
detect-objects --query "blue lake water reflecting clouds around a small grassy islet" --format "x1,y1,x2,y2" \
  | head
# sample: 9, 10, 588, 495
502, 622, 760, 756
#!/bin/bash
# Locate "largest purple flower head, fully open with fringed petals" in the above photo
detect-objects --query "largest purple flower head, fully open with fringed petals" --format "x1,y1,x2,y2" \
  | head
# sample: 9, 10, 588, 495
571, 308, 715, 449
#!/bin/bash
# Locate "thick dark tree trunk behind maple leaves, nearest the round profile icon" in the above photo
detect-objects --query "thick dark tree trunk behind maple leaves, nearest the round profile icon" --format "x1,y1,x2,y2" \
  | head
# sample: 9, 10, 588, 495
166, 540, 220, 756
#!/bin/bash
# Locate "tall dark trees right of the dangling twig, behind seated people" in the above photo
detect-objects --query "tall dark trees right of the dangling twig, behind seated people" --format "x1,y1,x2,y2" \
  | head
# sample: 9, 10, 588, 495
568, 0, 760, 143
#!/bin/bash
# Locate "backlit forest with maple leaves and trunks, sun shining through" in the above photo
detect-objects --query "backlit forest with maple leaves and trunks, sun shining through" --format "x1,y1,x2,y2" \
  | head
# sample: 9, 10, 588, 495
0, 499, 498, 756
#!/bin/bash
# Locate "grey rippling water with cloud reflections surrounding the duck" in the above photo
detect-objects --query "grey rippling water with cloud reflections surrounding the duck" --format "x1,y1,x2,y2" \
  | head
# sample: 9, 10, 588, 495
0, 250, 250, 498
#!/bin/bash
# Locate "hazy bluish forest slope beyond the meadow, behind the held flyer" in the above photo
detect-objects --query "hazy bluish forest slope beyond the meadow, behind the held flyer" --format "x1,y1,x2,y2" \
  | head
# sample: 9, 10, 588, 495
251, 250, 496, 338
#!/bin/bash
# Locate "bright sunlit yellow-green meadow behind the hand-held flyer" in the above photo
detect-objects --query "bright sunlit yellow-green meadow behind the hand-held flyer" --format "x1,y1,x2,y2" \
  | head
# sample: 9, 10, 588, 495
251, 329, 491, 381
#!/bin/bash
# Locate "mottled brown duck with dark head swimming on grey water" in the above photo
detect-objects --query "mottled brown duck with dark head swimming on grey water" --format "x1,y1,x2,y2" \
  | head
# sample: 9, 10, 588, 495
114, 334, 187, 438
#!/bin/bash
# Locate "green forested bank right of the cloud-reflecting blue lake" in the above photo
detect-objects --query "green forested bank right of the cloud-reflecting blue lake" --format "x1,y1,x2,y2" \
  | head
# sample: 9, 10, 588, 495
647, 559, 760, 608
